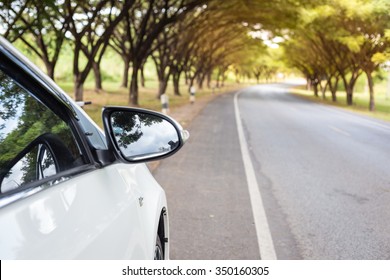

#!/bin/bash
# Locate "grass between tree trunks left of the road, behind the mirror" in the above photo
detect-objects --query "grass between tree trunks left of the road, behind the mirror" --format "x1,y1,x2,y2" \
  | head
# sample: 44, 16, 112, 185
58, 80, 246, 127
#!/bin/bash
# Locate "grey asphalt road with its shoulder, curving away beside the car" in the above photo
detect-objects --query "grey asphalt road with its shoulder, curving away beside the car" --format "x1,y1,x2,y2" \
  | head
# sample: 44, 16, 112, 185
155, 86, 390, 259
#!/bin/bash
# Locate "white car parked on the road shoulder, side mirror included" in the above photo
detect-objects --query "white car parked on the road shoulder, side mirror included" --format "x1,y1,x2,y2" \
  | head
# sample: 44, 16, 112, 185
0, 38, 188, 260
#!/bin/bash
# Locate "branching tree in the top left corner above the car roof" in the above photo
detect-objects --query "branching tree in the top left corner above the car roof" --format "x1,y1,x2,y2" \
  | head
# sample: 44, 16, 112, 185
0, 0, 70, 79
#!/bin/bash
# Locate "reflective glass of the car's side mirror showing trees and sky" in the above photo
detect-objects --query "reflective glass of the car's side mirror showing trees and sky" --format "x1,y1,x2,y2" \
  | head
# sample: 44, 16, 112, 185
110, 111, 180, 160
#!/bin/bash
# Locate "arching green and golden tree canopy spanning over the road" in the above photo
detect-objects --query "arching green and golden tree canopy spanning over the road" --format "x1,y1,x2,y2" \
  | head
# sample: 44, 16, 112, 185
0, 0, 390, 110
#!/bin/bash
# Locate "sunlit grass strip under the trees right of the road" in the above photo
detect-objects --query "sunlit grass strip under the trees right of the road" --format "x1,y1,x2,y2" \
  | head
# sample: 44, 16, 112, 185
290, 84, 390, 122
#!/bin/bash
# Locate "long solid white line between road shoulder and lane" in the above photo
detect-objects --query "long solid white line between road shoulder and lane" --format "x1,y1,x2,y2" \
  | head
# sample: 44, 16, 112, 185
234, 91, 277, 260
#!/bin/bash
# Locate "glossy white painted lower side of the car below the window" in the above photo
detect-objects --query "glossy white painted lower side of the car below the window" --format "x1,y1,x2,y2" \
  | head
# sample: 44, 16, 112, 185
0, 163, 166, 259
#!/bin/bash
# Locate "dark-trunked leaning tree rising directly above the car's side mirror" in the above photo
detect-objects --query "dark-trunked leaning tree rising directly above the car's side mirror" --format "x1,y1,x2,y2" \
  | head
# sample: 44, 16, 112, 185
113, 0, 205, 105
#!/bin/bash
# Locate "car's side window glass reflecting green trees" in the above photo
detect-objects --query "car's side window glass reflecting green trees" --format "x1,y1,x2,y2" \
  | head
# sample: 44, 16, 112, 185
0, 70, 84, 193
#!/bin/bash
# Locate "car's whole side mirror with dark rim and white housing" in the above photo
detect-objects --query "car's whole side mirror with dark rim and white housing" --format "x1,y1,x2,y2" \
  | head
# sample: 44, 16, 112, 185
103, 107, 189, 163
